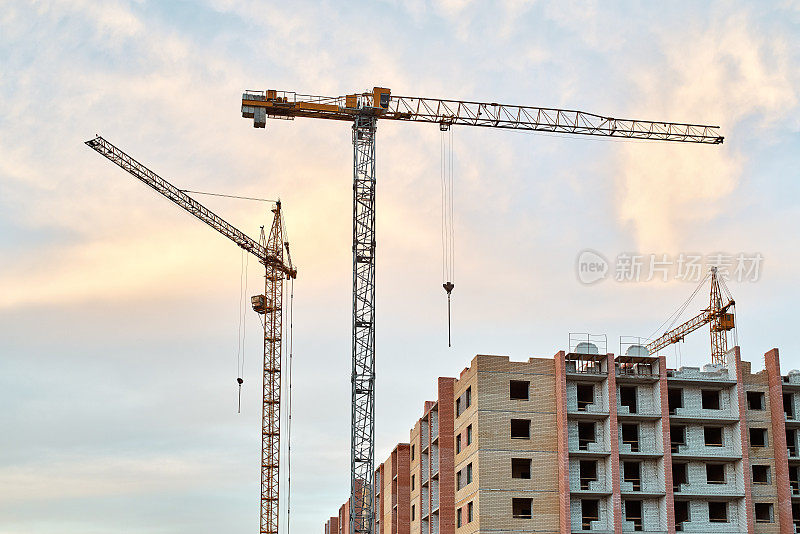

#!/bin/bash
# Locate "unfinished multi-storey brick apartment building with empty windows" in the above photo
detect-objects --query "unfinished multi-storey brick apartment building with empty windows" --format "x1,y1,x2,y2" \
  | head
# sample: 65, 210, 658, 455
325, 341, 800, 534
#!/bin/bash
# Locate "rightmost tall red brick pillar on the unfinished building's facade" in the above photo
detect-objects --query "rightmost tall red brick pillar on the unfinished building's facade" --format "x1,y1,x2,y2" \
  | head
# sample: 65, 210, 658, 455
764, 349, 794, 534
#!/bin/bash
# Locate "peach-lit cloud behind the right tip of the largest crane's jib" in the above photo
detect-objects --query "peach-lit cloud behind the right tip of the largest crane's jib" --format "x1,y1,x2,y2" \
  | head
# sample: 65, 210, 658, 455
613, 8, 800, 251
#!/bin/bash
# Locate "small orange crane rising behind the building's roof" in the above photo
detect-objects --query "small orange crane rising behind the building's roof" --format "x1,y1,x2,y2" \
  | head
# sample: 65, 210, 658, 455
647, 267, 736, 365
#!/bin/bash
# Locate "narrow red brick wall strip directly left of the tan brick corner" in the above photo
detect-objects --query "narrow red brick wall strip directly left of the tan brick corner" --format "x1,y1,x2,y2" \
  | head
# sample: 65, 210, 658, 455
439, 378, 456, 534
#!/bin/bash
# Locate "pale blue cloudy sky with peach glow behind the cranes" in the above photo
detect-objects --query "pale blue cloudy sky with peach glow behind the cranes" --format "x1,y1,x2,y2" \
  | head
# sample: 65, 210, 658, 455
0, 0, 800, 534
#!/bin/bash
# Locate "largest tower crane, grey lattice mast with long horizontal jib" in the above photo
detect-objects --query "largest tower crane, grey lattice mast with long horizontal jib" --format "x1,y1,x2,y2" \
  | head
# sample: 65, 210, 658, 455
242, 87, 723, 534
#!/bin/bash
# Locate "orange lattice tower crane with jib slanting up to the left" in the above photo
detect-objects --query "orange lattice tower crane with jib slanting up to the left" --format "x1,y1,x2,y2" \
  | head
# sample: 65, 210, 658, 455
86, 136, 297, 534
